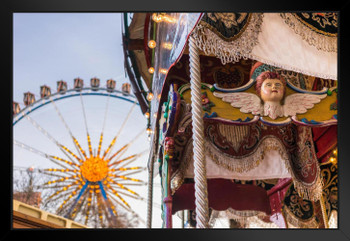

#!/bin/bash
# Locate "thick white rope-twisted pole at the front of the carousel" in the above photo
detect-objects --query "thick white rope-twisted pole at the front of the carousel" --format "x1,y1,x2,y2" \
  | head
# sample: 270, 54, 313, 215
189, 35, 209, 228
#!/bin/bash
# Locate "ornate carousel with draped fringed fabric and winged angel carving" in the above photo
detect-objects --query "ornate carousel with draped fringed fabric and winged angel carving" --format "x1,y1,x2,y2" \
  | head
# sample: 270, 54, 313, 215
123, 12, 338, 229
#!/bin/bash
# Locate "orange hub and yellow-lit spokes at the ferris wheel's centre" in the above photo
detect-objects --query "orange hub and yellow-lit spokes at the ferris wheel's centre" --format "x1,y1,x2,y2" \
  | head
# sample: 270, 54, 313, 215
40, 131, 144, 227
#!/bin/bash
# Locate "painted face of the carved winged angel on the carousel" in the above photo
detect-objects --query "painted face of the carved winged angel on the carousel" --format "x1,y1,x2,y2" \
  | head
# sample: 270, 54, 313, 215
260, 79, 284, 102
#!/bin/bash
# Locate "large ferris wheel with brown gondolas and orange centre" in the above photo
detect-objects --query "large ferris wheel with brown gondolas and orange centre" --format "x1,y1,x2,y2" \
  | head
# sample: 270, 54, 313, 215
13, 78, 156, 227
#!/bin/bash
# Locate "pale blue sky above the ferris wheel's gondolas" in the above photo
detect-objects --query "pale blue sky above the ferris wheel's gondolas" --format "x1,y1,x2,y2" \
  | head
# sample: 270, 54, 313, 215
13, 13, 126, 103
